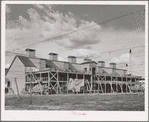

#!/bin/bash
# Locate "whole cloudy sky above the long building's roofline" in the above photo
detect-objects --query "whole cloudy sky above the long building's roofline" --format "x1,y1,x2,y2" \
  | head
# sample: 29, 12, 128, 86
5, 4, 145, 77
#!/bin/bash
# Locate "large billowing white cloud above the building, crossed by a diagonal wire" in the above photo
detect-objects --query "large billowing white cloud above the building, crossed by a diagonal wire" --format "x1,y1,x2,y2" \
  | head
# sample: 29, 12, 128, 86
6, 4, 101, 49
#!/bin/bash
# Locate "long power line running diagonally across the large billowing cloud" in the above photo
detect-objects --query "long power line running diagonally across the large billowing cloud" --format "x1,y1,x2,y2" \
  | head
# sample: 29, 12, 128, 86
12, 10, 145, 51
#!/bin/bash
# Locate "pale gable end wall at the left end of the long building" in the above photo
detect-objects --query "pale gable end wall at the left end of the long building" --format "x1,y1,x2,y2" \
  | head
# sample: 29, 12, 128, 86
6, 58, 25, 94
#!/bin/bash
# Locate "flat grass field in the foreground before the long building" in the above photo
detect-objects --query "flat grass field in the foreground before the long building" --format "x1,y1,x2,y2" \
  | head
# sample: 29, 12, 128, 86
5, 94, 145, 111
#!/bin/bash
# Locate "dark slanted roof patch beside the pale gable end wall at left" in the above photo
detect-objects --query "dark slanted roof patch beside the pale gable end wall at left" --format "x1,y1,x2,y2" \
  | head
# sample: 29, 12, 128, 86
18, 56, 36, 67
